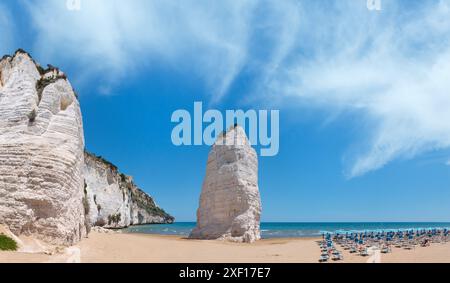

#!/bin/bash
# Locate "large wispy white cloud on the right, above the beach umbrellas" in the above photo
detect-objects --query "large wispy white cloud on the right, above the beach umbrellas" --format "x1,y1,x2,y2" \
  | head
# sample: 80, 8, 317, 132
271, 0, 450, 177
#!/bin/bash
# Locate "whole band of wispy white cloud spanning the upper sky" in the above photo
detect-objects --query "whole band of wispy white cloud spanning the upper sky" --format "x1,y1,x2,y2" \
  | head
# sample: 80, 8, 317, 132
16, 0, 450, 177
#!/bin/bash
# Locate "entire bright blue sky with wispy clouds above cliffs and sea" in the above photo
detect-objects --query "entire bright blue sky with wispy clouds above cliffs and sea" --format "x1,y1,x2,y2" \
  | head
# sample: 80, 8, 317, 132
0, 0, 450, 221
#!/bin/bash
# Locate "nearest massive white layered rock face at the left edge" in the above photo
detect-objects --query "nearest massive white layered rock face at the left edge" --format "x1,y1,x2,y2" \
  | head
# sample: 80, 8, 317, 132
0, 51, 87, 245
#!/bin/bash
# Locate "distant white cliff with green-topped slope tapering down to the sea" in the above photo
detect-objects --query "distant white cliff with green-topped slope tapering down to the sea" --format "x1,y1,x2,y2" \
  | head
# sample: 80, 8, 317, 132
83, 153, 174, 228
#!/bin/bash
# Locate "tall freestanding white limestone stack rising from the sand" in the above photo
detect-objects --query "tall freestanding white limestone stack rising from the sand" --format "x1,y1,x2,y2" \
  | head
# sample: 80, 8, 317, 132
190, 126, 261, 243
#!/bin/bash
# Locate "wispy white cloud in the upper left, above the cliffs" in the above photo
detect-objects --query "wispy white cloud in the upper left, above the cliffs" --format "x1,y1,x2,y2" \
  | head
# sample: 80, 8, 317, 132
25, 0, 256, 99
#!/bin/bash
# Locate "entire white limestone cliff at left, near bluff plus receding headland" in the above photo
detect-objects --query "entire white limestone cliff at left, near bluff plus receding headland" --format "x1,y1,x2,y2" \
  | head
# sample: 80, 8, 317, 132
0, 50, 173, 245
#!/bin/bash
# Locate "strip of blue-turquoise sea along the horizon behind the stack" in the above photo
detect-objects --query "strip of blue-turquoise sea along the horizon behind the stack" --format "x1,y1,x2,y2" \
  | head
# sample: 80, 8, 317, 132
124, 222, 450, 239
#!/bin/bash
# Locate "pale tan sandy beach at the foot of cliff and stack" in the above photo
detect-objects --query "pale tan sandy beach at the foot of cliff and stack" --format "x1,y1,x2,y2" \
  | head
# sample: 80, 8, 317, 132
0, 233, 450, 263
